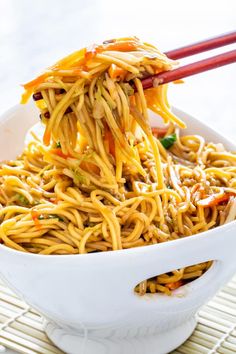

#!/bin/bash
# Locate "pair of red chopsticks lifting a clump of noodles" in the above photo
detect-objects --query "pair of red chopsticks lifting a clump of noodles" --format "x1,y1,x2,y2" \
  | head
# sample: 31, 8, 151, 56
142, 32, 236, 89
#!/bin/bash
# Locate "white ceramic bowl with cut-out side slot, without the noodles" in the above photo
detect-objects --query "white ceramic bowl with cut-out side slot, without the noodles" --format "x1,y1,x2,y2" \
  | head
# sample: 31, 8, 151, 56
0, 104, 236, 354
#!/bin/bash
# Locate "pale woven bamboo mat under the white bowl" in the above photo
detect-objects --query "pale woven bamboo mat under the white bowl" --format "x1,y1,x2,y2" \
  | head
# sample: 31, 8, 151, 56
0, 277, 236, 354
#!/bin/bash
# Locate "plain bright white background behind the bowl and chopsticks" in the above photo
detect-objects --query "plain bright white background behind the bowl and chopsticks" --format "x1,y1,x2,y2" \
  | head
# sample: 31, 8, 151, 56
0, 0, 236, 140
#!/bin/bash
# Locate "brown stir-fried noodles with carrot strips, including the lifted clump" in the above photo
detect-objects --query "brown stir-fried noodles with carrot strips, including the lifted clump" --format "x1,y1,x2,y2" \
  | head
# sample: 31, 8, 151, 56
0, 37, 236, 295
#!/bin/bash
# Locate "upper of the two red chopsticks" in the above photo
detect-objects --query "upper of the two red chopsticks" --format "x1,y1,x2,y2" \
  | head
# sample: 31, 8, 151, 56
165, 31, 236, 60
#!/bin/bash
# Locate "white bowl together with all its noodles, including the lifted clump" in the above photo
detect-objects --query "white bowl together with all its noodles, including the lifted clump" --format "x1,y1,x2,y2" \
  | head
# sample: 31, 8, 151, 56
0, 37, 236, 354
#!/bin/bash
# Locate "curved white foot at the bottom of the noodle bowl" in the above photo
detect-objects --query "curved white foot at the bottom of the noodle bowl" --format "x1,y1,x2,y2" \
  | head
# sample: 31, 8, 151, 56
45, 317, 196, 354
